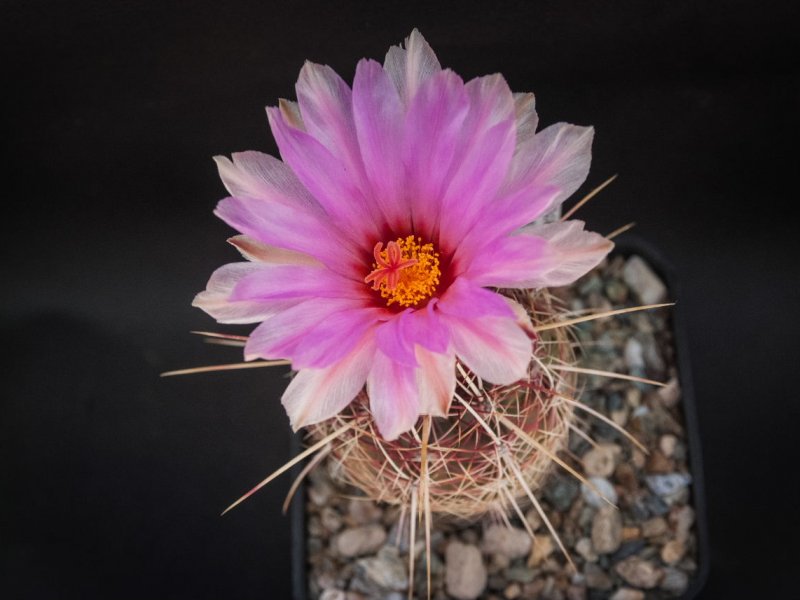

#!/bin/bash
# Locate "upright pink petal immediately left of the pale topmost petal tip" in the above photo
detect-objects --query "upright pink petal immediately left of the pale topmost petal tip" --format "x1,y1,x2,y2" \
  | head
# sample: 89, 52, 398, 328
353, 59, 411, 231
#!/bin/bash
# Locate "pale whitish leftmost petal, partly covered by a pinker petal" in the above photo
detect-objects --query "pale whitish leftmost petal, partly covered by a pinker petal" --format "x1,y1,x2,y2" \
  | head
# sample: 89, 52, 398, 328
192, 262, 285, 323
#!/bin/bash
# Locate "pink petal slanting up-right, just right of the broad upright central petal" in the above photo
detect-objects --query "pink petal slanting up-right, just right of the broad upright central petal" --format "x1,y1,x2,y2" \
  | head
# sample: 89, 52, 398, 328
434, 75, 515, 252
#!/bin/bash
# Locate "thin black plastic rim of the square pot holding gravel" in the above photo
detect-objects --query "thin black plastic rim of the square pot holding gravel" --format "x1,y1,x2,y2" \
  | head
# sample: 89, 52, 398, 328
290, 235, 710, 600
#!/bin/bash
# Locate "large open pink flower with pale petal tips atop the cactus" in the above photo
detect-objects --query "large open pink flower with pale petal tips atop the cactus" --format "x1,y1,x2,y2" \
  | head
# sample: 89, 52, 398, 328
194, 30, 612, 440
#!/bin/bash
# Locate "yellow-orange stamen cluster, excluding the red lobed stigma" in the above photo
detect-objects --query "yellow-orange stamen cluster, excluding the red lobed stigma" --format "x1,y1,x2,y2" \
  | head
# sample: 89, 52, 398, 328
372, 235, 442, 307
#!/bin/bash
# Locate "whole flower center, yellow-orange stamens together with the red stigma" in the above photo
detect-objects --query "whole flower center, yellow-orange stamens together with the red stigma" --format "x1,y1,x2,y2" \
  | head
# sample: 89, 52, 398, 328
364, 235, 442, 306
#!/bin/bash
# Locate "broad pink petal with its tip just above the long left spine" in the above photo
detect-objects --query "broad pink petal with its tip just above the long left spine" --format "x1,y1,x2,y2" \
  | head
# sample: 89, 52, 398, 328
245, 299, 384, 369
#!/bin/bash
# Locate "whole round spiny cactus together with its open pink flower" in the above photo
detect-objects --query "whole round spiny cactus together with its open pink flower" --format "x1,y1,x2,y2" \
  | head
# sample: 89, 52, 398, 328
167, 31, 668, 600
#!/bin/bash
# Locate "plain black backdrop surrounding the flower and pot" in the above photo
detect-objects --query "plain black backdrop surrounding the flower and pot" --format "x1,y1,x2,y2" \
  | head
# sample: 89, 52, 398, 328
0, 1, 800, 598
